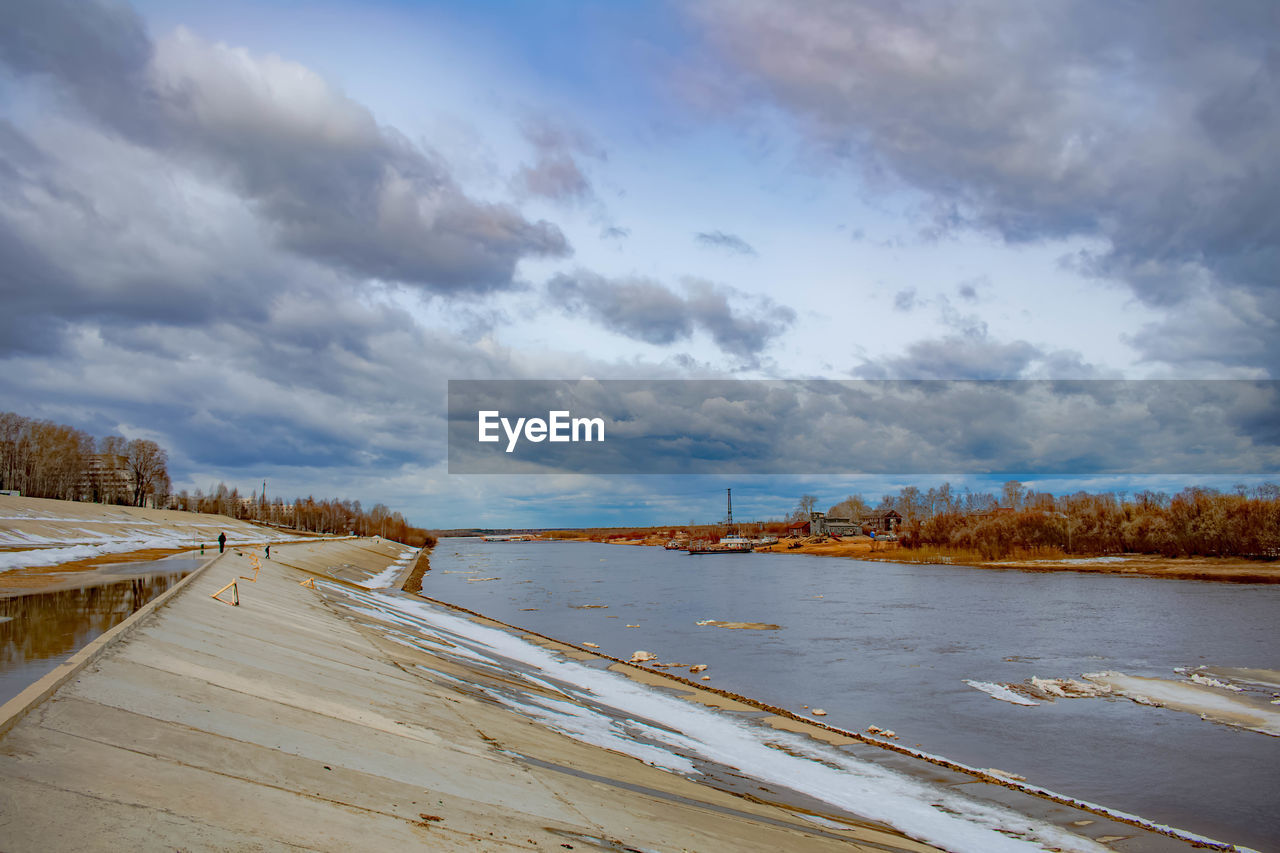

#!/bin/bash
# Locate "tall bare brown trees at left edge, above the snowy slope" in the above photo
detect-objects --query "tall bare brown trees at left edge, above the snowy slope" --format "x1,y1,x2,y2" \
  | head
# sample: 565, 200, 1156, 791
0, 411, 169, 506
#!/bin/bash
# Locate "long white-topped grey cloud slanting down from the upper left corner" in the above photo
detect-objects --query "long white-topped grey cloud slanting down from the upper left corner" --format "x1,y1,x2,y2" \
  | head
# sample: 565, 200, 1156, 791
0, 0, 568, 295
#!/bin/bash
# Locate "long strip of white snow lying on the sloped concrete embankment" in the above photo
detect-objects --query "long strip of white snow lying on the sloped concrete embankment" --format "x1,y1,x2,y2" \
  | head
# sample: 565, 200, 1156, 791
321, 584, 1126, 853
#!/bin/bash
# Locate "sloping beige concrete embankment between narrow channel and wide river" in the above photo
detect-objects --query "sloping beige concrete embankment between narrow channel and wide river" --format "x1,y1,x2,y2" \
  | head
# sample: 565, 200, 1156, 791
0, 539, 1239, 853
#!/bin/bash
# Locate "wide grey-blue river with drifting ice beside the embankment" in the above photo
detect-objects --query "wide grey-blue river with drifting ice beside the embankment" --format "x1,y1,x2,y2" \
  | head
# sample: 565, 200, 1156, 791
422, 539, 1280, 850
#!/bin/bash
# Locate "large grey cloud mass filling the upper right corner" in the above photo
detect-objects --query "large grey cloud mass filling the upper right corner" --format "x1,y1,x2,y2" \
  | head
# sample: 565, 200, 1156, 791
691, 0, 1280, 371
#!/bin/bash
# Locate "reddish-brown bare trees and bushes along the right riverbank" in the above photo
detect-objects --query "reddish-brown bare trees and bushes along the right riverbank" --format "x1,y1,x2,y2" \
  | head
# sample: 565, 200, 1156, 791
832, 480, 1280, 560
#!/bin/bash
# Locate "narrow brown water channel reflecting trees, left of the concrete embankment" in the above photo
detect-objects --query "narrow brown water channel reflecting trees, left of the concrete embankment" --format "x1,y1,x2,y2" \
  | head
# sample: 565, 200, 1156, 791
0, 558, 204, 703
